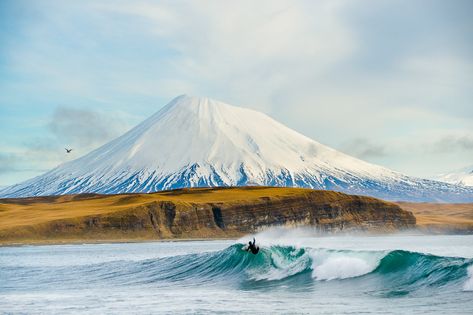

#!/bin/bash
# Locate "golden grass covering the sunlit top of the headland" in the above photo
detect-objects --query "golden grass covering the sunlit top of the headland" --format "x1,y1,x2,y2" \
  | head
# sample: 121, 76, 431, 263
0, 187, 314, 230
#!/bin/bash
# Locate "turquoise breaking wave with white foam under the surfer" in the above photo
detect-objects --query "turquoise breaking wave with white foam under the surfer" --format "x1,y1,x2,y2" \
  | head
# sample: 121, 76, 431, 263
24, 244, 473, 295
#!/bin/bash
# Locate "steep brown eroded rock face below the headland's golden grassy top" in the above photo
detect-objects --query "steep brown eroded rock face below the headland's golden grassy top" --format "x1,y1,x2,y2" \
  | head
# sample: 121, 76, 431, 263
48, 192, 416, 239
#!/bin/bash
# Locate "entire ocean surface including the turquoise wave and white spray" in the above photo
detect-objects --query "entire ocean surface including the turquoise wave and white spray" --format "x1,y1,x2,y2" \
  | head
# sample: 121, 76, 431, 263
0, 230, 473, 314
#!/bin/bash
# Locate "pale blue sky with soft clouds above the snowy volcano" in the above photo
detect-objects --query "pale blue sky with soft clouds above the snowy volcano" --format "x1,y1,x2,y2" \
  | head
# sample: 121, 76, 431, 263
0, 0, 473, 186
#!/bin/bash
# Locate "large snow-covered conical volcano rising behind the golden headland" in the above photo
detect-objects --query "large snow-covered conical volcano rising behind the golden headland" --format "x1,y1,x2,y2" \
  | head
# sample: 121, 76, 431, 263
0, 96, 473, 201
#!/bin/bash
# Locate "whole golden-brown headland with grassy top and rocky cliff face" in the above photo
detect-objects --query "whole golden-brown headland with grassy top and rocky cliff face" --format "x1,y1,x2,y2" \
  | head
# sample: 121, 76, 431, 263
0, 187, 416, 244
